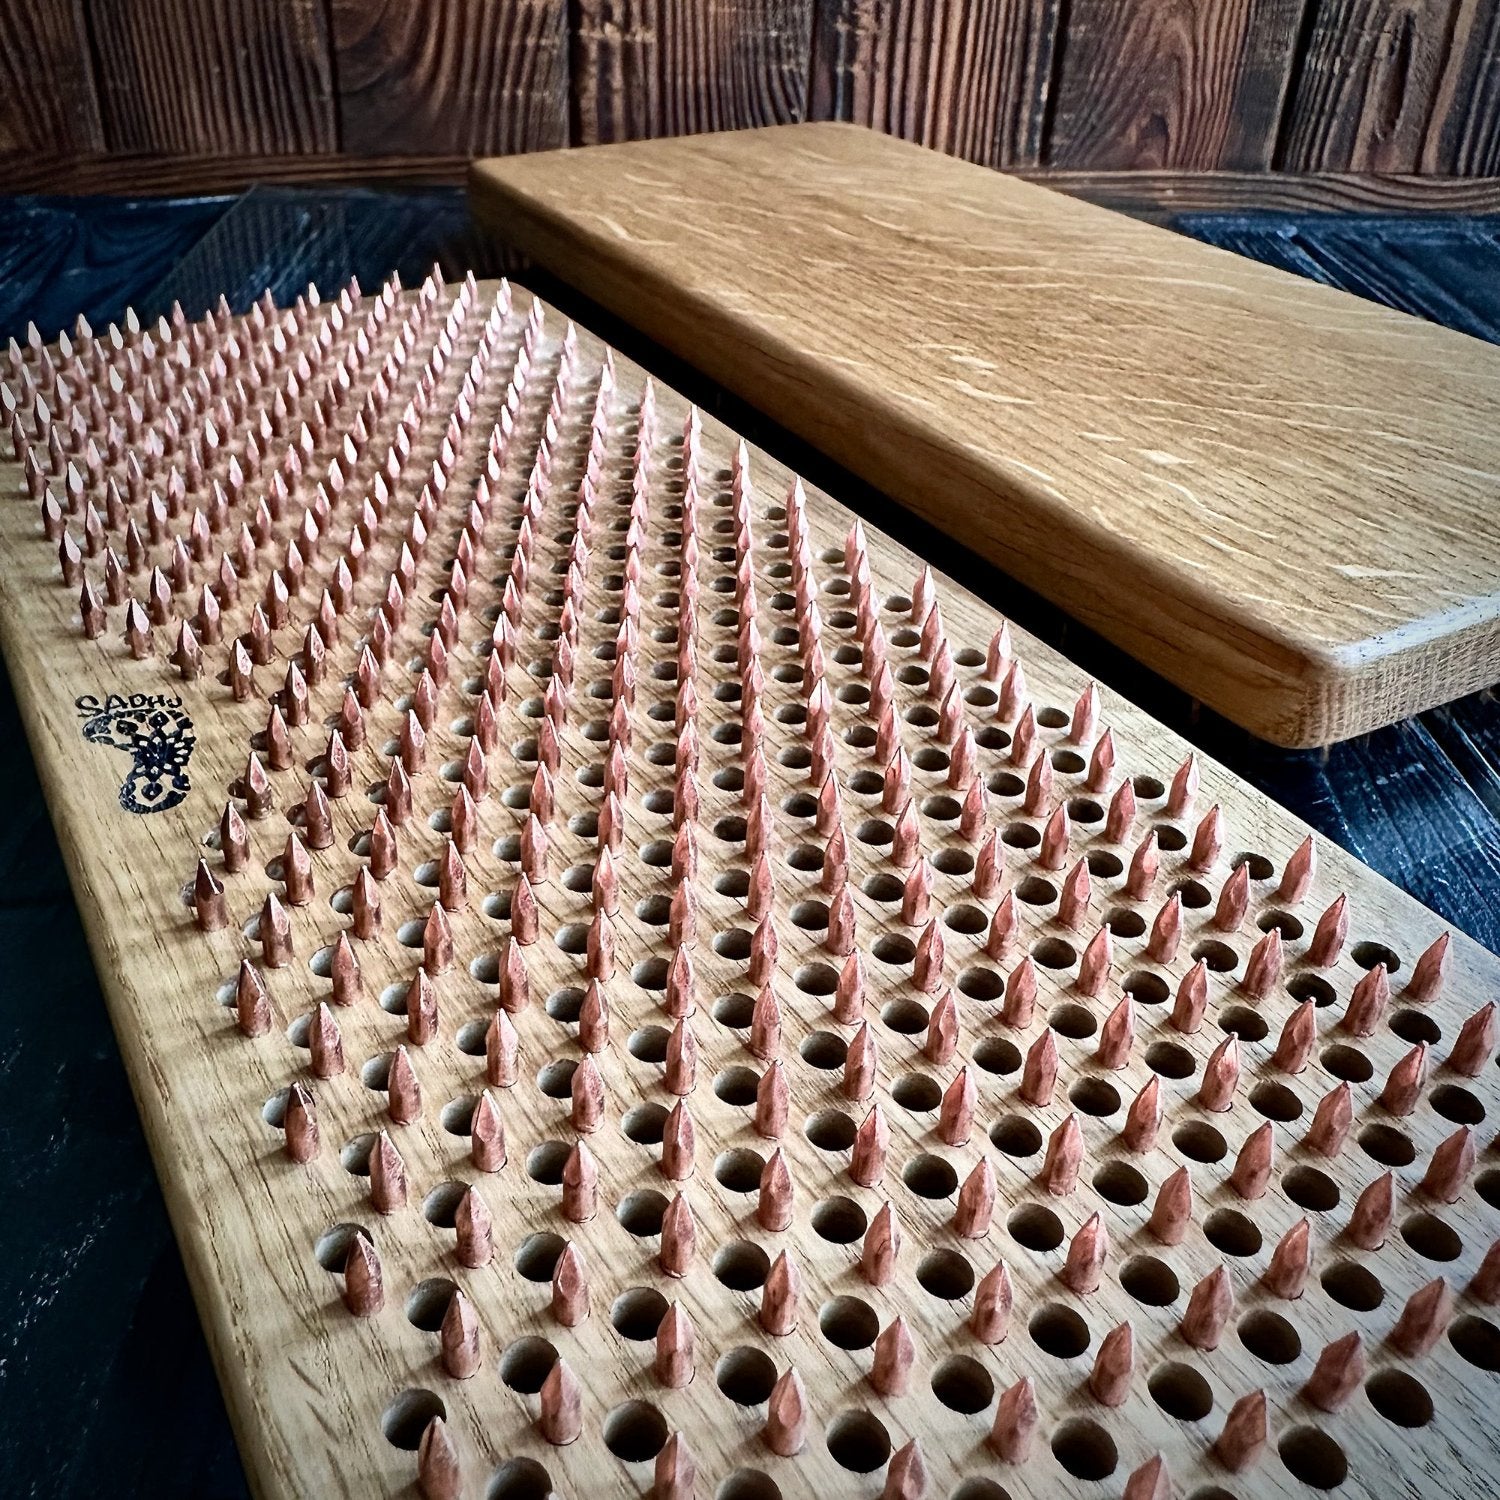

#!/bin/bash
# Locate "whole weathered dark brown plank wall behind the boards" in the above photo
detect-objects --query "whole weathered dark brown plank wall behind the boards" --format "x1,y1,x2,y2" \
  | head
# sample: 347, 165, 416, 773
0, 0, 1500, 197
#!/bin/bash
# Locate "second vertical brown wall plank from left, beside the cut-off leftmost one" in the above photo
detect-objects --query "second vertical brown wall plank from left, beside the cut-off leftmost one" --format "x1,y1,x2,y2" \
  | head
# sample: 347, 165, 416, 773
90, 0, 339, 156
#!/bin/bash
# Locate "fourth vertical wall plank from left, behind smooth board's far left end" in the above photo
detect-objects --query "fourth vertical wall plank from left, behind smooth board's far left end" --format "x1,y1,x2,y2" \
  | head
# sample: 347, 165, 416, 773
573, 0, 813, 146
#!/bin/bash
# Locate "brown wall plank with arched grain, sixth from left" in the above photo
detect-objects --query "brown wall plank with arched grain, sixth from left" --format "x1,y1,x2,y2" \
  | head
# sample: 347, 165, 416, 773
1047, 0, 1304, 171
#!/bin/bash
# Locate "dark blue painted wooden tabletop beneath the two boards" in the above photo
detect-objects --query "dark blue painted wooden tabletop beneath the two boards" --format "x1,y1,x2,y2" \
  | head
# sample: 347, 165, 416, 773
0, 189, 1500, 1500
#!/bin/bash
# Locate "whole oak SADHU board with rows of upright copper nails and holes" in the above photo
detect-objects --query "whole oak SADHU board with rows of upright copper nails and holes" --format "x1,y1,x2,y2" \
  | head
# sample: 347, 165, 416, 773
0, 279, 1500, 1500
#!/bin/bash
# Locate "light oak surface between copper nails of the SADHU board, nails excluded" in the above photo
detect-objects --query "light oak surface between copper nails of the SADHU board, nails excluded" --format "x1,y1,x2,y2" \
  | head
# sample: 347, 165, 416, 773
0, 276, 1500, 1500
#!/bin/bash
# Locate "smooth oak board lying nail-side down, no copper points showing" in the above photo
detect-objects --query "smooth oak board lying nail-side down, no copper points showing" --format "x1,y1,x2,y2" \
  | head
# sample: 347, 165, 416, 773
473, 125, 1500, 746
